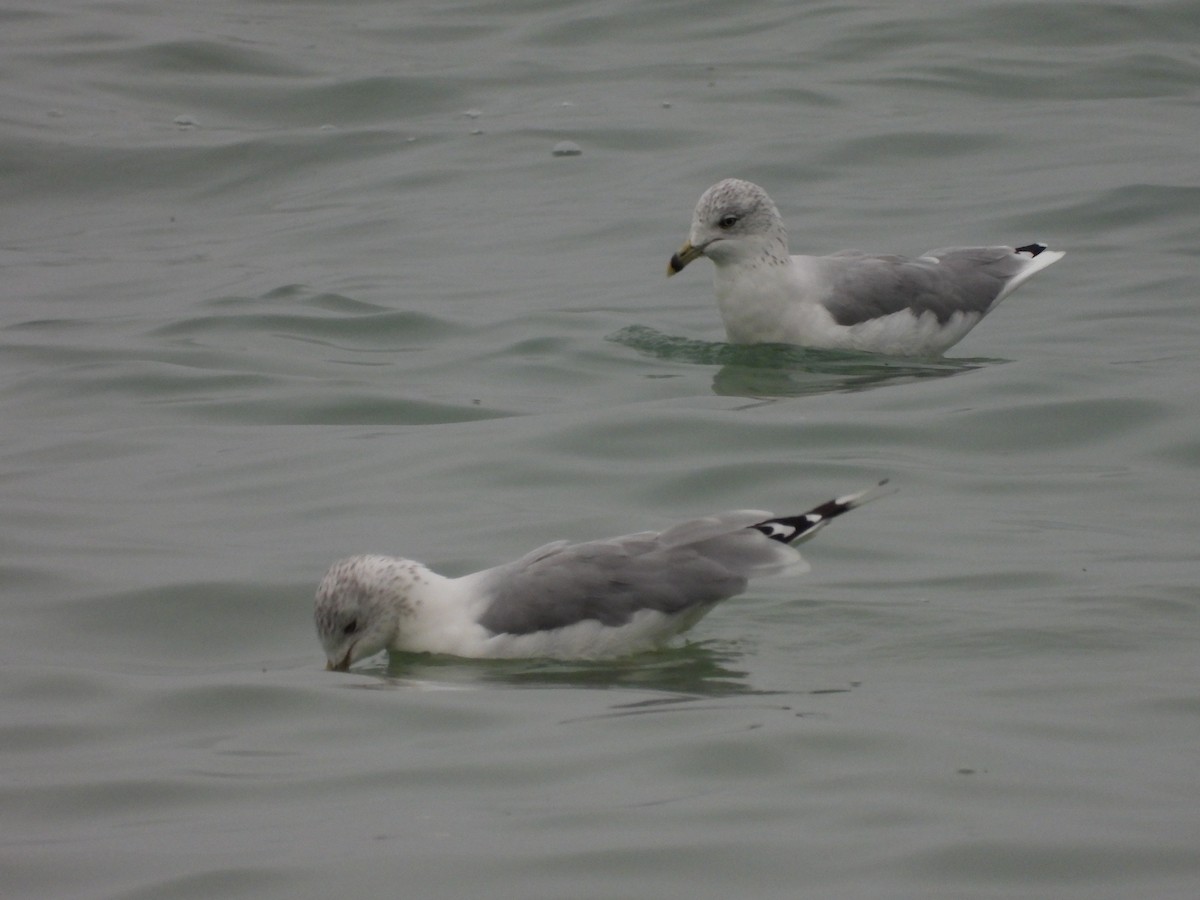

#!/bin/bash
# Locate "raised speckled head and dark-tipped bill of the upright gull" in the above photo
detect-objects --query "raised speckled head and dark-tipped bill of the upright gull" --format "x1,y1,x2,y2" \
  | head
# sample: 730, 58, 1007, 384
667, 178, 788, 277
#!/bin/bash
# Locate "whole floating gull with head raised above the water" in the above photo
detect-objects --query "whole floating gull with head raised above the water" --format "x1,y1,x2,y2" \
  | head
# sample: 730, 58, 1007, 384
667, 178, 1064, 356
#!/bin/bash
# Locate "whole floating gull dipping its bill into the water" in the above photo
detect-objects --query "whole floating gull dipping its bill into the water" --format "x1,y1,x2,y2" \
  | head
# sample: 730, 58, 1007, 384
314, 481, 887, 671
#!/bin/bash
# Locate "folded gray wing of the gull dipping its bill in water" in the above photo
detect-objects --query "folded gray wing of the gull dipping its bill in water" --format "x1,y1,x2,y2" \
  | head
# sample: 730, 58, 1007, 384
479, 518, 804, 635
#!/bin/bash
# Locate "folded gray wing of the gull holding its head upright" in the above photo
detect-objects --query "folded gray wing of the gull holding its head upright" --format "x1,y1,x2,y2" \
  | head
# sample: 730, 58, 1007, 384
821, 247, 1031, 325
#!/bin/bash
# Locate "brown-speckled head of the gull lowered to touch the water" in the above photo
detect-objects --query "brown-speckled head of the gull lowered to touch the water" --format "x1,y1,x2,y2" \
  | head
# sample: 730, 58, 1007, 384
313, 556, 424, 672
